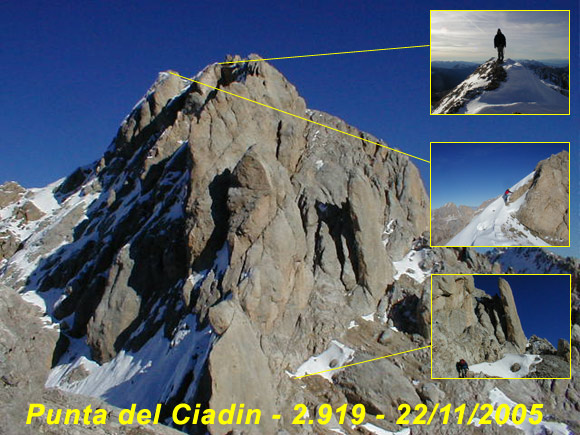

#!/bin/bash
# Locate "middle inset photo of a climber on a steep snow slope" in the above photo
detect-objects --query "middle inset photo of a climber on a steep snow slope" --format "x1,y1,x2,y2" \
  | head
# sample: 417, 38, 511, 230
430, 142, 570, 247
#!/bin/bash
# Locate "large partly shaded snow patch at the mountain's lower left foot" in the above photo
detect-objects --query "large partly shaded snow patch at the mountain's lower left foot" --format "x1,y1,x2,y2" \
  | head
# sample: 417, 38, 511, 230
46, 314, 214, 409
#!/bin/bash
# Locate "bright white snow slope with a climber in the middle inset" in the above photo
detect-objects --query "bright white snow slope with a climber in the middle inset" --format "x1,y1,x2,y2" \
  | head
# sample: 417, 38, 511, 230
447, 172, 546, 246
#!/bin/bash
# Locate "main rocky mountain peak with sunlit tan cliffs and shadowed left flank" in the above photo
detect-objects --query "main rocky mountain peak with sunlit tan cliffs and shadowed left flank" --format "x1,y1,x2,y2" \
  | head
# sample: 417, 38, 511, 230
2, 56, 428, 430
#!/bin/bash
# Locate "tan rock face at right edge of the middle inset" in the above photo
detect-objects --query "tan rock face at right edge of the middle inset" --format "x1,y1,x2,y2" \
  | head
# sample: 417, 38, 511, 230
517, 151, 570, 246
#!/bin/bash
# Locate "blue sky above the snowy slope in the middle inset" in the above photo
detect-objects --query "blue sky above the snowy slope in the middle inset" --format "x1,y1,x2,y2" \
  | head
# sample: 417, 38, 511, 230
431, 143, 568, 208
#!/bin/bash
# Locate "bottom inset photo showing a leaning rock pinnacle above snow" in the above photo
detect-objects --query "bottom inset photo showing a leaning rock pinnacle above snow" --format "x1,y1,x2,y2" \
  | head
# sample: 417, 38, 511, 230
431, 274, 571, 379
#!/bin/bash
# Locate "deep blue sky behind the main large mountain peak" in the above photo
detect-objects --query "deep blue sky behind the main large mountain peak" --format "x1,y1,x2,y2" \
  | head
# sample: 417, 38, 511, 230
0, 0, 580, 255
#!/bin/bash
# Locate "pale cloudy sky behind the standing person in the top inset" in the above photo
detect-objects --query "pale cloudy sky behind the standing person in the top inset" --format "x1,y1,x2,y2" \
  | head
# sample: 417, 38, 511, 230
431, 11, 569, 62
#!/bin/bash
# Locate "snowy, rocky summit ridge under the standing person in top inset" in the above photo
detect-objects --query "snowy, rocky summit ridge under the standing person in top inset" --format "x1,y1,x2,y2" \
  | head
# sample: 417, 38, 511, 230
433, 59, 568, 114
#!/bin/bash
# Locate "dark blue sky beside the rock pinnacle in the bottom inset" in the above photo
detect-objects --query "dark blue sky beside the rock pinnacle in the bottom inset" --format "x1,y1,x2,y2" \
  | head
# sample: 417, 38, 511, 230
474, 275, 570, 347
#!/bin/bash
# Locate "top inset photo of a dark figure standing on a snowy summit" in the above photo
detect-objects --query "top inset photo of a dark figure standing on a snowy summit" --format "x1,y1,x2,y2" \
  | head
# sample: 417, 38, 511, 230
430, 11, 570, 115
